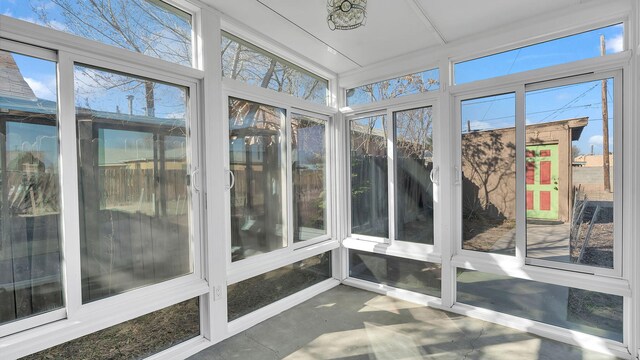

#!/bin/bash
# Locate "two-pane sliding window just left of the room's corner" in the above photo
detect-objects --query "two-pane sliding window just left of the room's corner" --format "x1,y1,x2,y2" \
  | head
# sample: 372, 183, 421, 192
229, 97, 330, 261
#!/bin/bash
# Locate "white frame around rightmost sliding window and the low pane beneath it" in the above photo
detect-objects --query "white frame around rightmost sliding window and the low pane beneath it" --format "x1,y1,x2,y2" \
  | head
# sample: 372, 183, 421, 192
443, 36, 637, 354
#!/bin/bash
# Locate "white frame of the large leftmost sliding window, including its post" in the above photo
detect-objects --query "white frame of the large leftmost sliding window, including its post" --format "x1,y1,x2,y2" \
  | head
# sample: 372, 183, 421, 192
0, 5, 214, 358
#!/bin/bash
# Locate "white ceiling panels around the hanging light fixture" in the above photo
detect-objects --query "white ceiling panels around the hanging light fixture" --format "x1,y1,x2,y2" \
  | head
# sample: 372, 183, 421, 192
203, 0, 587, 73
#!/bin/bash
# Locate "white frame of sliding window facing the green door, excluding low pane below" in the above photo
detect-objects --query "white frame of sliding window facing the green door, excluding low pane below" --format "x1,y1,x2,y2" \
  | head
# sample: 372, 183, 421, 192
451, 57, 631, 286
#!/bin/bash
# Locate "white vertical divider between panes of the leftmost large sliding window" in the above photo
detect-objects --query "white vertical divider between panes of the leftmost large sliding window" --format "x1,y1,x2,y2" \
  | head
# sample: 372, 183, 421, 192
58, 51, 82, 319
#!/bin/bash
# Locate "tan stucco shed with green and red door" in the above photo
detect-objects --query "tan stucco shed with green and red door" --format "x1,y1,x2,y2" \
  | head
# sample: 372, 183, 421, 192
462, 118, 588, 222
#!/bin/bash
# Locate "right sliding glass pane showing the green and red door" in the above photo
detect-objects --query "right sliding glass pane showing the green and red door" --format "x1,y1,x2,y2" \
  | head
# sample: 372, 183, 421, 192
526, 79, 615, 269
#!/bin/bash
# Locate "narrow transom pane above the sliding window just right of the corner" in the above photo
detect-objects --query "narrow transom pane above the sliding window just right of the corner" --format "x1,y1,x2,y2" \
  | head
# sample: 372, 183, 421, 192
347, 69, 440, 105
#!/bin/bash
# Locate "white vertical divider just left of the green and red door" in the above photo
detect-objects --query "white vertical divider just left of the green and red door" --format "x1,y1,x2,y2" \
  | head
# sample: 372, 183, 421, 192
515, 85, 527, 265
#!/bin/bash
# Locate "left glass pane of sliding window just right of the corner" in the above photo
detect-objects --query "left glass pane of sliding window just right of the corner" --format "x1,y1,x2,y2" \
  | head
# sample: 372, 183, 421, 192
350, 115, 389, 238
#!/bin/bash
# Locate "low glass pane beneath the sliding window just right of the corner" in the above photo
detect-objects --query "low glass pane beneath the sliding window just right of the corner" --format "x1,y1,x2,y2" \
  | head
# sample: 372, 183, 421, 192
349, 250, 442, 297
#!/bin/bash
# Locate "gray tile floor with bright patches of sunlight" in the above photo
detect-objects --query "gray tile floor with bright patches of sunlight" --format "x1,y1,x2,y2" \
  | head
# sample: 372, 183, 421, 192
190, 285, 615, 360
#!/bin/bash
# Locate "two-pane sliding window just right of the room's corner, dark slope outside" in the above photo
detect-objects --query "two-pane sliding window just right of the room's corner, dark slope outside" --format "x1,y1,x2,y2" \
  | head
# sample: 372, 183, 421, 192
349, 106, 436, 245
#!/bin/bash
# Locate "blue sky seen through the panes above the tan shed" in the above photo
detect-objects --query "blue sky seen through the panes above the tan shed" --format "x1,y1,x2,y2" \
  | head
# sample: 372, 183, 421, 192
454, 25, 624, 154
